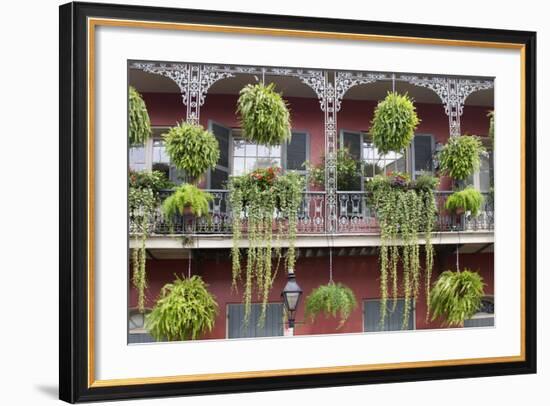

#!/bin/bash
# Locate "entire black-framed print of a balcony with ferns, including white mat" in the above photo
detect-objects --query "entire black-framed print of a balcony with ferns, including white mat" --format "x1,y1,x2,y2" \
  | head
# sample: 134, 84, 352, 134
60, 3, 536, 402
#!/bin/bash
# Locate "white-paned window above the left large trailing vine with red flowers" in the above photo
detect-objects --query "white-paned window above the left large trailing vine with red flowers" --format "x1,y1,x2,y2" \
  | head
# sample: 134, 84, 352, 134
233, 138, 281, 175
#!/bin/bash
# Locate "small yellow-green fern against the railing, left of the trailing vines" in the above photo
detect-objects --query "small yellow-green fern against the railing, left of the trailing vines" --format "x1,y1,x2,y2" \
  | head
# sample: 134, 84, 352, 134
162, 183, 213, 218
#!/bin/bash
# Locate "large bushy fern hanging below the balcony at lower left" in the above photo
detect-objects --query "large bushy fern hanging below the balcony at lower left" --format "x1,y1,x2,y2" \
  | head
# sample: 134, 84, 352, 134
145, 275, 218, 341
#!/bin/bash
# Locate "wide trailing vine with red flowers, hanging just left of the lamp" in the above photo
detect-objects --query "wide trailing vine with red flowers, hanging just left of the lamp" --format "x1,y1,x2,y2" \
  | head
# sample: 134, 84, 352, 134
228, 167, 304, 325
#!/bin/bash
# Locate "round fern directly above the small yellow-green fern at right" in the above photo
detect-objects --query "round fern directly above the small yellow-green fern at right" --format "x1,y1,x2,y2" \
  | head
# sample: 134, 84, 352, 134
439, 135, 485, 180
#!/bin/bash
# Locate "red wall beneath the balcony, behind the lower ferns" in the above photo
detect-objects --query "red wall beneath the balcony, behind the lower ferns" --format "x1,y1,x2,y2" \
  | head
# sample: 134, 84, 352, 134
130, 254, 494, 339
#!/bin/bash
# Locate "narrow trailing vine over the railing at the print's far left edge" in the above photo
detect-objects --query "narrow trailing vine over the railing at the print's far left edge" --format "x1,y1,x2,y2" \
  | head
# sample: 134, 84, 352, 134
128, 186, 157, 313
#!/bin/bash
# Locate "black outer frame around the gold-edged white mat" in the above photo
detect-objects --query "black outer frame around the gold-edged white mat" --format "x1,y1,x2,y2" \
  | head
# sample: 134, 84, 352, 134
59, 3, 536, 403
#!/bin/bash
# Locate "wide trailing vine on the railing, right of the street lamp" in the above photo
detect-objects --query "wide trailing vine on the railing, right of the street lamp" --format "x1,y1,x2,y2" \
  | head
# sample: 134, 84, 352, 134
367, 173, 438, 328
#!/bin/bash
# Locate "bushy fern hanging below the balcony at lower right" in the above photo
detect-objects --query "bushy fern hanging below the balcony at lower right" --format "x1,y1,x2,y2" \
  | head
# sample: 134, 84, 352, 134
430, 269, 485, 326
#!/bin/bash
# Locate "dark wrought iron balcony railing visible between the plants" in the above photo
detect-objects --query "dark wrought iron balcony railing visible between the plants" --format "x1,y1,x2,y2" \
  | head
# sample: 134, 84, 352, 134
130, 190, 494, 235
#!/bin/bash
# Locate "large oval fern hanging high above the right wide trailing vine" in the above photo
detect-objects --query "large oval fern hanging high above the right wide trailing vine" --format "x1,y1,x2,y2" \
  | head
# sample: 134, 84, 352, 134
370, 92, 420, 154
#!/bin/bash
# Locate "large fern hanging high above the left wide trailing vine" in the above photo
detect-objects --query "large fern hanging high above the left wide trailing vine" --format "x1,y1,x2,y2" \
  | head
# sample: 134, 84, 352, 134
237, 83, 291, 146
